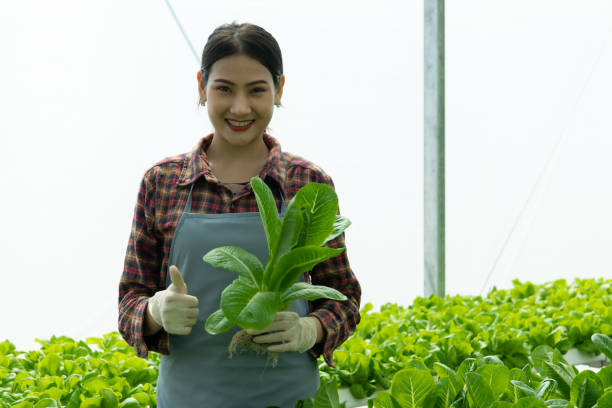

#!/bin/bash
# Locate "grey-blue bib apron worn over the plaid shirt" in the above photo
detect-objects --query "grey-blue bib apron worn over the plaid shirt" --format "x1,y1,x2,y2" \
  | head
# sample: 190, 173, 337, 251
157, 182, 319, 408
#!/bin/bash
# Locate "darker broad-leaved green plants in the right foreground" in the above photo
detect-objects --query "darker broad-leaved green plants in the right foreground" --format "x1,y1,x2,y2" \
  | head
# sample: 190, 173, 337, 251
297, 334, 612, 408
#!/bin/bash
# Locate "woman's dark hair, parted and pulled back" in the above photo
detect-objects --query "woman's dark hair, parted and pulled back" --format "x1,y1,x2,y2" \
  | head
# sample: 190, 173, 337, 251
201, 21, 283, 87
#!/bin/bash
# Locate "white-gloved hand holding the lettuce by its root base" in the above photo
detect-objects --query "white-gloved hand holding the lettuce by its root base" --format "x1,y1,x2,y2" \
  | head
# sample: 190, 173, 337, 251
247, 312, 317, 353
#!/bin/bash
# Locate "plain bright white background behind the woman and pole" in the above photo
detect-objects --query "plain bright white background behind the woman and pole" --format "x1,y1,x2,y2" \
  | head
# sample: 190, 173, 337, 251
0, 0, 612, 349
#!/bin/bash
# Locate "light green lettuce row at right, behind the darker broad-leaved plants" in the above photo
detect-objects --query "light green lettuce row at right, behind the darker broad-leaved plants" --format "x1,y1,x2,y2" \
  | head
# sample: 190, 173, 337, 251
319, 279, 612, 398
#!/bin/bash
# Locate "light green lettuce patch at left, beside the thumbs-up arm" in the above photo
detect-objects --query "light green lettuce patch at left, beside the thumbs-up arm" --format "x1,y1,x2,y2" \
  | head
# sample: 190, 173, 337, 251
0, 332, 160, 408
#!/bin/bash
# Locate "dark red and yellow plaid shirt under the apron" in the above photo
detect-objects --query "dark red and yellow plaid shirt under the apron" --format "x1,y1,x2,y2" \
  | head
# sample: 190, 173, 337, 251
119, 133, 361, 366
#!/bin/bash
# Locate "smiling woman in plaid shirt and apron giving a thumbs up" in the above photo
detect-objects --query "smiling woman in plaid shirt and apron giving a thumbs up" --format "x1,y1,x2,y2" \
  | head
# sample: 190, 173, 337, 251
119, 23, 361, 408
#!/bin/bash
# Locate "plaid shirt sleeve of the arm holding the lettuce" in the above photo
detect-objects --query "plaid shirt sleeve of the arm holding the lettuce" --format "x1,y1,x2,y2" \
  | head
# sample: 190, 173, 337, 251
289, 168, 361, 367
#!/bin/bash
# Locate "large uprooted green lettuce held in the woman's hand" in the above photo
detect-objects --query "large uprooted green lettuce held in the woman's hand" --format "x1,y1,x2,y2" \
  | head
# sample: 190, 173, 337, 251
203, 177, 350, 334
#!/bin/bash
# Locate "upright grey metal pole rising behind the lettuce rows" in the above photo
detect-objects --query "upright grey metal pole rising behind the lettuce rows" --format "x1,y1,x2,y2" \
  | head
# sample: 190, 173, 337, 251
424, 0, 446, 297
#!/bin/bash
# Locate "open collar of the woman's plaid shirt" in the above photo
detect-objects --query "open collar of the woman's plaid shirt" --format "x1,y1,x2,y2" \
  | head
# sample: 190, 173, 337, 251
178, 133, 287, 193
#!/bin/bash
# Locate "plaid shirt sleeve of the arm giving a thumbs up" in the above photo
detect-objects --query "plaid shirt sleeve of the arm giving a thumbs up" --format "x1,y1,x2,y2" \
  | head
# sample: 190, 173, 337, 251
118, 168, 169, 358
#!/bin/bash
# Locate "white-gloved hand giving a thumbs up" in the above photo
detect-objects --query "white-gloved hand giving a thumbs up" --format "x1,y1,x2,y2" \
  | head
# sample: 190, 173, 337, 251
148, 265, 200, 335
